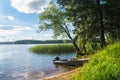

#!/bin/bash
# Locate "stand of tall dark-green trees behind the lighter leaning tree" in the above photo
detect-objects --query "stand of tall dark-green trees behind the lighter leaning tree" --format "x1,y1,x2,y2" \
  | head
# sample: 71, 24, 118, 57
57, 0, 120, 51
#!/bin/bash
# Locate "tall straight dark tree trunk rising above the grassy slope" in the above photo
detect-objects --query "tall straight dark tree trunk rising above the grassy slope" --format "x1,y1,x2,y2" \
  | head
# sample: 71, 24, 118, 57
96, 0, 106, 49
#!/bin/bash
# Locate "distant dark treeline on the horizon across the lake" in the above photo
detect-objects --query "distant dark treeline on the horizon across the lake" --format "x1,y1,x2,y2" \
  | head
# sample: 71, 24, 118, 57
0, 40, 71, 44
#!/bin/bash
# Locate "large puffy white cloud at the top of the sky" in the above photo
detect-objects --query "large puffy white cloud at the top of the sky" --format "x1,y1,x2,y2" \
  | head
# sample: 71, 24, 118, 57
11, 0, 51, 14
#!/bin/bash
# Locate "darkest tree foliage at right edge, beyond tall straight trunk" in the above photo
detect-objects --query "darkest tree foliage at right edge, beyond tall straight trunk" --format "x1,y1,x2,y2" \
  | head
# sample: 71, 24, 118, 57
102, 0, 120, 42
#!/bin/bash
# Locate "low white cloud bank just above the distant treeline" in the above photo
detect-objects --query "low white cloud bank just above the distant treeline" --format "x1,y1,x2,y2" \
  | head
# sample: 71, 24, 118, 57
0, 25, 53, 41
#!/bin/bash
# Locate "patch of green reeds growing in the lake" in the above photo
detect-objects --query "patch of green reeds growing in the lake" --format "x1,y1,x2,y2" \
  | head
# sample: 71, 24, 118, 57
30, 44, 75, 53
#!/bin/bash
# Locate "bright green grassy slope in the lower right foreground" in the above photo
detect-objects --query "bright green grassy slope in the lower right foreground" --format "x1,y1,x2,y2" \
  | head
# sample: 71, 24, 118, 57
71, 42, 120, 80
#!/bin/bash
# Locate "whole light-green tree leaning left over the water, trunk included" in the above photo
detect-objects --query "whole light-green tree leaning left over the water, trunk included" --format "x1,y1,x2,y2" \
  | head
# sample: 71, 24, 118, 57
40, 5, 82, 55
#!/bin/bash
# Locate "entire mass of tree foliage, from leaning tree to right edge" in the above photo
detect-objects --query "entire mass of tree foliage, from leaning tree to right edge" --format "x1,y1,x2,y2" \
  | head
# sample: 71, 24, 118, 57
39, 0, 120, 54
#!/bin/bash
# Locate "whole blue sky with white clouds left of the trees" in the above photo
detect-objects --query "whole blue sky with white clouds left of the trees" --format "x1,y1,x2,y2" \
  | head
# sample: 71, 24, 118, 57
0, 0, 55, 42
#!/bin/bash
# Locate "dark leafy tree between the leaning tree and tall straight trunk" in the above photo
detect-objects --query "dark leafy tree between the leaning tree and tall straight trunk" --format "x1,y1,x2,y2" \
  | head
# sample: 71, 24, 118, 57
57, 0, 103, 52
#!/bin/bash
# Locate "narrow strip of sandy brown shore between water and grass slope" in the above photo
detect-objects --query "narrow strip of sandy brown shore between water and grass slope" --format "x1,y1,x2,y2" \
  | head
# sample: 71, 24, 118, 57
39, 68, 80, 80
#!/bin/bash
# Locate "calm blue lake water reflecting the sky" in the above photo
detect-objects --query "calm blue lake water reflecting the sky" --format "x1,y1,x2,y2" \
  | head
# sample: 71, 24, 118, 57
0, 44, 75, 80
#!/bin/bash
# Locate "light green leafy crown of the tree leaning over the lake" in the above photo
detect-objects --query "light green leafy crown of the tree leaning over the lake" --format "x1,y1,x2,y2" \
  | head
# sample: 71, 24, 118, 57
39, 5, 69, 38
